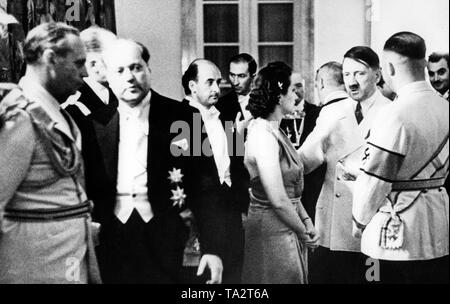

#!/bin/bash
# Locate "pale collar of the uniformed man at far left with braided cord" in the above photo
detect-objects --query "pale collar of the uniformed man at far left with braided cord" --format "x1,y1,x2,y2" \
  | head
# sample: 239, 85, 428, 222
19, 76, 75, 140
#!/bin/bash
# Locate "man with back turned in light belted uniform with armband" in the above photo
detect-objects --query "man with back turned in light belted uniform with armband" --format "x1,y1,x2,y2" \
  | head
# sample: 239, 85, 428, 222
353, 32, 449, 283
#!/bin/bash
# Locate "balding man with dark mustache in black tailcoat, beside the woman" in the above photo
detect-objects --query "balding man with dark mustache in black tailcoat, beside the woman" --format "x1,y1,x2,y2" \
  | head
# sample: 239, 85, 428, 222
172, 59, 249, 284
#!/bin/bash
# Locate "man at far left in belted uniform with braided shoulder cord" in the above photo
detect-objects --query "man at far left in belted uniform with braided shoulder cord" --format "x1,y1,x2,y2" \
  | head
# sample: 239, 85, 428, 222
0, 23, 100, 284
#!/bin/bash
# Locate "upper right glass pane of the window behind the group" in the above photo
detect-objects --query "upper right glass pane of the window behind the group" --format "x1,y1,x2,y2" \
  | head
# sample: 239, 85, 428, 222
258, 3, 294, 42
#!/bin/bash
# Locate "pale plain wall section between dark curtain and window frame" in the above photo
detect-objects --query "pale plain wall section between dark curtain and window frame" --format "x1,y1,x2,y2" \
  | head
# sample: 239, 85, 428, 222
115, 0, 182, 100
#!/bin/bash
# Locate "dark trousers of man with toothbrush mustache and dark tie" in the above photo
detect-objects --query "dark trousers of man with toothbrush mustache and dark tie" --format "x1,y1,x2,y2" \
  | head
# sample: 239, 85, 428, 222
308, 246, 368, 284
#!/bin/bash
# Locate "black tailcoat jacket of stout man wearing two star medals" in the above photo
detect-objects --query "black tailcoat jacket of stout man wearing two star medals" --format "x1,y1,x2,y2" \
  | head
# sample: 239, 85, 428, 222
65, 87, 188, 280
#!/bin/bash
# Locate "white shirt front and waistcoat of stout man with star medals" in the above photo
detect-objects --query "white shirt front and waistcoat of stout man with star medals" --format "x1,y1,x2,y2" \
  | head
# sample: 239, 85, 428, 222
114, 92, 153, 223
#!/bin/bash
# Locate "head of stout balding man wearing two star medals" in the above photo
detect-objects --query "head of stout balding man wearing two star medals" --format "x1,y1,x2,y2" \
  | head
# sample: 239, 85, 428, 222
103, 39, 150, 107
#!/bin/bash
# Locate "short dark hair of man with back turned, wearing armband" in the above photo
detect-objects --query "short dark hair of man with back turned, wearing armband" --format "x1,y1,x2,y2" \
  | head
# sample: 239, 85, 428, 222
383, 32, 427, 60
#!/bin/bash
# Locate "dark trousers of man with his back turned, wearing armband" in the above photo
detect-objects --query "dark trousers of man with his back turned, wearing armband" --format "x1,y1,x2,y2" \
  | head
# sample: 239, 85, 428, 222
380, 255, 449, 284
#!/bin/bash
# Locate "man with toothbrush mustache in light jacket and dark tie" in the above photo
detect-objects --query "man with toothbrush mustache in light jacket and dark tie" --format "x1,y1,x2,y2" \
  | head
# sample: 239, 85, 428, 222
299, 46, 390, 283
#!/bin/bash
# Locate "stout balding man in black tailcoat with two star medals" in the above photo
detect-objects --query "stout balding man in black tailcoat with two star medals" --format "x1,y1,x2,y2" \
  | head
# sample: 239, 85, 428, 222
90, 39, 188, 284
